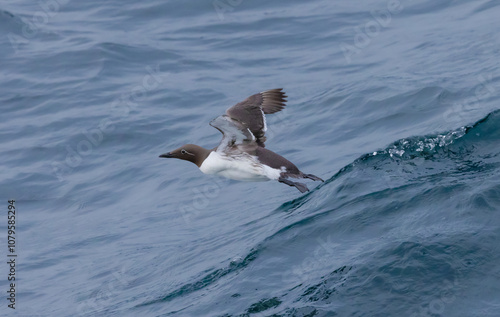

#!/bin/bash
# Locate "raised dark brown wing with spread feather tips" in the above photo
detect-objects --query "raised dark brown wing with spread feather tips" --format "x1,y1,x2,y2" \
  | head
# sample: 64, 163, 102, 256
226, 88, 287, 147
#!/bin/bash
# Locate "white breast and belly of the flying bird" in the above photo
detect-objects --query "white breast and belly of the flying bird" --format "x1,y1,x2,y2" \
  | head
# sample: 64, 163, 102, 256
200, 151, 282, 182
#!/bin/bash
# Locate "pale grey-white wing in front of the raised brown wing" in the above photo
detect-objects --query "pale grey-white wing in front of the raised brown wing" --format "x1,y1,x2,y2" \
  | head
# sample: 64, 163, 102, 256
210, 115, 258, 152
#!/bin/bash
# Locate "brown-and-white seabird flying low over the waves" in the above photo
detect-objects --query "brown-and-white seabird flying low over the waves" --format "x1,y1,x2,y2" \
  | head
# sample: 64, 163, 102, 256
160, 88, 323, 193
